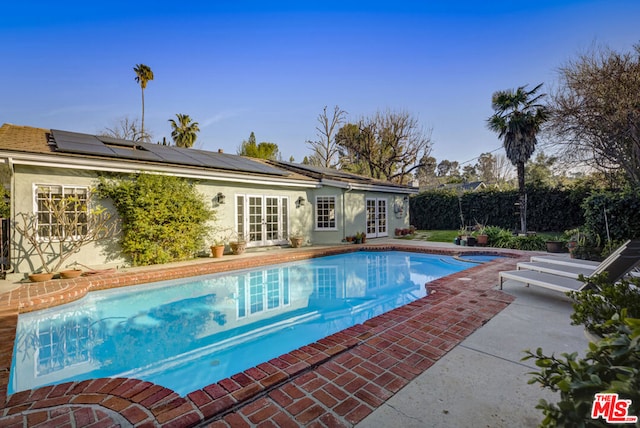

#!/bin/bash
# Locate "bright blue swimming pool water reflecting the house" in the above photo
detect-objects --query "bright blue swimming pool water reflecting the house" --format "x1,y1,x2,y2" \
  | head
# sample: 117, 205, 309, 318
9, 251, 496, 395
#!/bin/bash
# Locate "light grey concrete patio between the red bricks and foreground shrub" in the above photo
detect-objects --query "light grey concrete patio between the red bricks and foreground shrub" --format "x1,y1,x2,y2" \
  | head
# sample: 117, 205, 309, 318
357, 281, 588, 428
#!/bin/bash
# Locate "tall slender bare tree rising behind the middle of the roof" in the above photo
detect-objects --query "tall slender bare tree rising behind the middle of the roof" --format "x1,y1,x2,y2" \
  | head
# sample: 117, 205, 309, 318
307, 106, 347, 168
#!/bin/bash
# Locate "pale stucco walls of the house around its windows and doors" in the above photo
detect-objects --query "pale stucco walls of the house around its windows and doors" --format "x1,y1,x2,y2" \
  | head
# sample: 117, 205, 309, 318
11, 165, 409, 273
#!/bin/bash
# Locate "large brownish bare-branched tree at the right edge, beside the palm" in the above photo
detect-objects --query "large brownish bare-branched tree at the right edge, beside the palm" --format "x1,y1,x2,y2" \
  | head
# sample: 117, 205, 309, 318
550, 45, 640, 187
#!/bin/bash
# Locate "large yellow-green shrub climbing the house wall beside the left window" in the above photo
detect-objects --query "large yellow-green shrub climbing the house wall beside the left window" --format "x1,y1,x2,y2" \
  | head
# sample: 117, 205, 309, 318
98, 174, 214, 266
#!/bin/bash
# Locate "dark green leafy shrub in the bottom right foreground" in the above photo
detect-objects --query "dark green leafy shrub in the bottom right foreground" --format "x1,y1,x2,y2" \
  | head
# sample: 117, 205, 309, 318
523, 274, 640, 427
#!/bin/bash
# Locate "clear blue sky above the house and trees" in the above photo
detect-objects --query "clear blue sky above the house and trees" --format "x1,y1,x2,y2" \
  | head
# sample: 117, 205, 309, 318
0, 0, 640, 166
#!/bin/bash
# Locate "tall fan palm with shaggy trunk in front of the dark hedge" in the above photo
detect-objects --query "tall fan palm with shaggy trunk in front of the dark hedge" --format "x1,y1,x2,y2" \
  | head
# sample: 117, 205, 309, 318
487, 83, 549, 233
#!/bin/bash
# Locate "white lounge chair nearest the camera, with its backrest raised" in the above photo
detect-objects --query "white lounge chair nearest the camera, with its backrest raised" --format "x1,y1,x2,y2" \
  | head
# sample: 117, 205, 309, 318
499, 239, 640, 291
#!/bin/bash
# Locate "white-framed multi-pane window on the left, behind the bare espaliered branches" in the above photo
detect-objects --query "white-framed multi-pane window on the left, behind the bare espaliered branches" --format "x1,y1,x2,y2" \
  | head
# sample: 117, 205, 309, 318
36, 185, 89, 240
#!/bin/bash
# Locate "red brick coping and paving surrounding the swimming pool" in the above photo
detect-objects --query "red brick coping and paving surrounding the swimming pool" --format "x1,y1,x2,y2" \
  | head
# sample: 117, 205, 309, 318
0, 244, 524, 427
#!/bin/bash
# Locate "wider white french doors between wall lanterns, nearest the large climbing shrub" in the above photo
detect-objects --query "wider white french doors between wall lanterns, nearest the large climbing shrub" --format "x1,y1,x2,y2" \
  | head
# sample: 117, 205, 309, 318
236, 195, 289, 247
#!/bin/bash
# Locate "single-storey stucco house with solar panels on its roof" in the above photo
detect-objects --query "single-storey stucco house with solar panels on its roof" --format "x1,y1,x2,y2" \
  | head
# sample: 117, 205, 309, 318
0, 124, 417, 273
